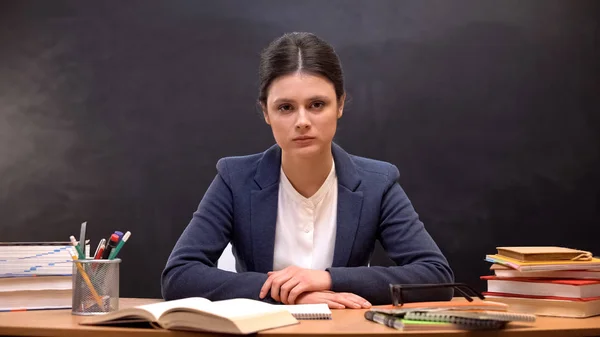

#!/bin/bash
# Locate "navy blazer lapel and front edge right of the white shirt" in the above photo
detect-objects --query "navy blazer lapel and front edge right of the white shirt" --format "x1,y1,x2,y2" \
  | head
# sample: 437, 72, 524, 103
332, 143, 363, 267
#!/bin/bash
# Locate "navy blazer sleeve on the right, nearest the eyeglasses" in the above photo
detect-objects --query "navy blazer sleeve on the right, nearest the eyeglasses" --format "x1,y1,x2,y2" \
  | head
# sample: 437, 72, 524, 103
328, 165, 454, 305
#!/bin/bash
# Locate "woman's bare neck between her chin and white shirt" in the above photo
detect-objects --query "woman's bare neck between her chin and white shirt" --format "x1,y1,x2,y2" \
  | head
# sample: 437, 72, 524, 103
281, 146, 333, 198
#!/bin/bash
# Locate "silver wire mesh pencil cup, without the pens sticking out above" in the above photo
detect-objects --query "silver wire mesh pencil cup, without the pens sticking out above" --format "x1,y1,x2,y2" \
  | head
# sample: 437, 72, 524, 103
71, 259, 121, 315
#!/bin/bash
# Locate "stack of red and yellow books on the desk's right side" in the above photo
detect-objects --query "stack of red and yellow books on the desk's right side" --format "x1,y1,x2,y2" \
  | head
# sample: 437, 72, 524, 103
481, 246, 600, 318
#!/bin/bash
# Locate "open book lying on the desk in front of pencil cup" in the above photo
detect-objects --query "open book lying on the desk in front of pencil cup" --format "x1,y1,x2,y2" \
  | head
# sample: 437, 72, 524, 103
80, 297, 298, 334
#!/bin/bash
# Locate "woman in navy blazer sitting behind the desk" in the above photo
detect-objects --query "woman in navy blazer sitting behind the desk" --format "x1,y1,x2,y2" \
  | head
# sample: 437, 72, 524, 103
162, 33, 454, 308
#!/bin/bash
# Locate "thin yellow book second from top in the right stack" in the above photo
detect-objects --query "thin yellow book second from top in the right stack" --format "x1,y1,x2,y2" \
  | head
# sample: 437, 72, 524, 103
485, 254, 600, 271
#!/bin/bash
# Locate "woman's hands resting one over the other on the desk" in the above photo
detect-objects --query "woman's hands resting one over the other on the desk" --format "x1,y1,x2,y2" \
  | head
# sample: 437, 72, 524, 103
259, 266, 371, 308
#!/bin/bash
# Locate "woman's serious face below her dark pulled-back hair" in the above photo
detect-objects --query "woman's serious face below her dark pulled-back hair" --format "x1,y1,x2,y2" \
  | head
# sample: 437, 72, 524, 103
262, 72, 344, 157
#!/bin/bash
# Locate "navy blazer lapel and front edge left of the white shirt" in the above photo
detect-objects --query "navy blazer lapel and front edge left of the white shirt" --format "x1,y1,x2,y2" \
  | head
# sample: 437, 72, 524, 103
250, 145, 281, 273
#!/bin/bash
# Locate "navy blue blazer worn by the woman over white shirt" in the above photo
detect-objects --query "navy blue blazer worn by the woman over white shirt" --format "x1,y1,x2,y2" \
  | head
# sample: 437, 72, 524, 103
161, 143, 454, 305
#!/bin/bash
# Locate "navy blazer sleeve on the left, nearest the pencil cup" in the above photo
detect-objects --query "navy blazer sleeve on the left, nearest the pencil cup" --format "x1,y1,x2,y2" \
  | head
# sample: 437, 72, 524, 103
161, 160, 275, 303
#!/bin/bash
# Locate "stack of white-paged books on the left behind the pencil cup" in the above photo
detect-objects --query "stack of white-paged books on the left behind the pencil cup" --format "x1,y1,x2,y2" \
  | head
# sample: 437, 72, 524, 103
0, 242, 81, 311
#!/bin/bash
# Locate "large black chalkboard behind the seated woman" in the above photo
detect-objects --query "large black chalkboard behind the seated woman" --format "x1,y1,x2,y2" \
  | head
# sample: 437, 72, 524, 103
0, 0, 600, 297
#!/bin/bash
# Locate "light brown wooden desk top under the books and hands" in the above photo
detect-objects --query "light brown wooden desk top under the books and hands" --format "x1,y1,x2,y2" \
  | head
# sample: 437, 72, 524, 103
0, 298, 600, 337
